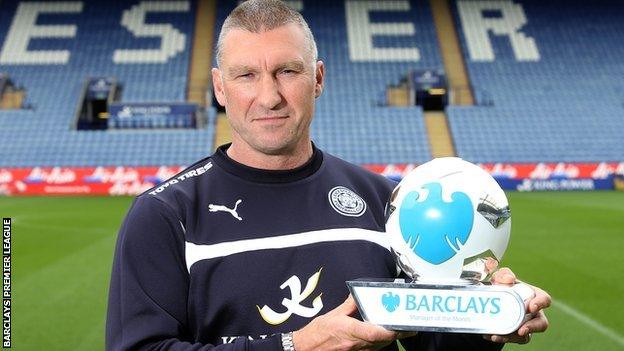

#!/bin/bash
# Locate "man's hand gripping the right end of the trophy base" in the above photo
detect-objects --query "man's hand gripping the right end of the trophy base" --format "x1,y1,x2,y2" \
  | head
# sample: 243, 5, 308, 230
484, 268, 552, 344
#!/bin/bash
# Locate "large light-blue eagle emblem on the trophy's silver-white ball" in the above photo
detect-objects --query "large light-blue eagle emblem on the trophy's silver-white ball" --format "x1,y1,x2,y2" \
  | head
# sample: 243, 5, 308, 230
399, 183, 474, 265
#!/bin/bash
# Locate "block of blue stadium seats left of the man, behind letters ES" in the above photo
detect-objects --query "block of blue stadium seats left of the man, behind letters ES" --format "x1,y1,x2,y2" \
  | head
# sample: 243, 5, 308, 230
0, 1, 214, 167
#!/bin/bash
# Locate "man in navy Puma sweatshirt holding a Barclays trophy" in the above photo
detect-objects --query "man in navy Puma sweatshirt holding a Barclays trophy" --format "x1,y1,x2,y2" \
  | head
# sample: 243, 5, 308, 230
106, 0, 550, 351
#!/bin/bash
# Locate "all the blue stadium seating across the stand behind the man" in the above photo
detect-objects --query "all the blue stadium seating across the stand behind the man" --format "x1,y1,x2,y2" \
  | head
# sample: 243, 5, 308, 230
0, 0, 624, 167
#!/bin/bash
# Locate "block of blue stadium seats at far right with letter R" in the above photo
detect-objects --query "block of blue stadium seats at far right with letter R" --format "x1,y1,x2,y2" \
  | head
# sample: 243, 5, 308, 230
447, 0, 624, 162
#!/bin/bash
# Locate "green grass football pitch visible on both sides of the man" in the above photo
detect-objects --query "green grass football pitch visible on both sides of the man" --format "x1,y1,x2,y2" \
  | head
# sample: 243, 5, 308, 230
0, 192, 624, 351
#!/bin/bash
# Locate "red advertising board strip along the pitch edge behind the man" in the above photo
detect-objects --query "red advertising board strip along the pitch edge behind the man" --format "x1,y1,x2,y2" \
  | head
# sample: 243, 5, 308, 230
0, 162, 624, 195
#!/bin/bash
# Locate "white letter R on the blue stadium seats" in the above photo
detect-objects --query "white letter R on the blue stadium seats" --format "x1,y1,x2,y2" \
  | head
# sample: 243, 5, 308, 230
457, 0, 540, 62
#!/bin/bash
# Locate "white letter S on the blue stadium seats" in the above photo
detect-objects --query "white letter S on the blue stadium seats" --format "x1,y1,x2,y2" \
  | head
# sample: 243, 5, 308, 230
113, 1, 191, 63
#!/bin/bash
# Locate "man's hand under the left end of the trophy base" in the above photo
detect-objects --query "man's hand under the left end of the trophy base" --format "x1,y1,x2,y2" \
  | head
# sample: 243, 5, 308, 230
293, 295, 416, 351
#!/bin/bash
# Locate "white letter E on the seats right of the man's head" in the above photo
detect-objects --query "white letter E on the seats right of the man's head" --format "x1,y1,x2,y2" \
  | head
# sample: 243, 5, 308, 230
345, 0, 420, 61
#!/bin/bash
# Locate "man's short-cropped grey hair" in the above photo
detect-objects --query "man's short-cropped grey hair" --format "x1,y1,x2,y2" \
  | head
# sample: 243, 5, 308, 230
216, 0, 318, 66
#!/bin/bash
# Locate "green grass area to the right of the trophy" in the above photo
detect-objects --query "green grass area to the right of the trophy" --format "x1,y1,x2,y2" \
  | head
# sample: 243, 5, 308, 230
494, 192, 624, 350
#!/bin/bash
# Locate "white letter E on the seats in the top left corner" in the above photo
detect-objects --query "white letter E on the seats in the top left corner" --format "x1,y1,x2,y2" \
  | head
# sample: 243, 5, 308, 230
0, 1, 83, 65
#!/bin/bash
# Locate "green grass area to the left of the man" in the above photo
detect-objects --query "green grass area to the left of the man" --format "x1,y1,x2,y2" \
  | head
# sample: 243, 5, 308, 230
0, 197, 131, 350
